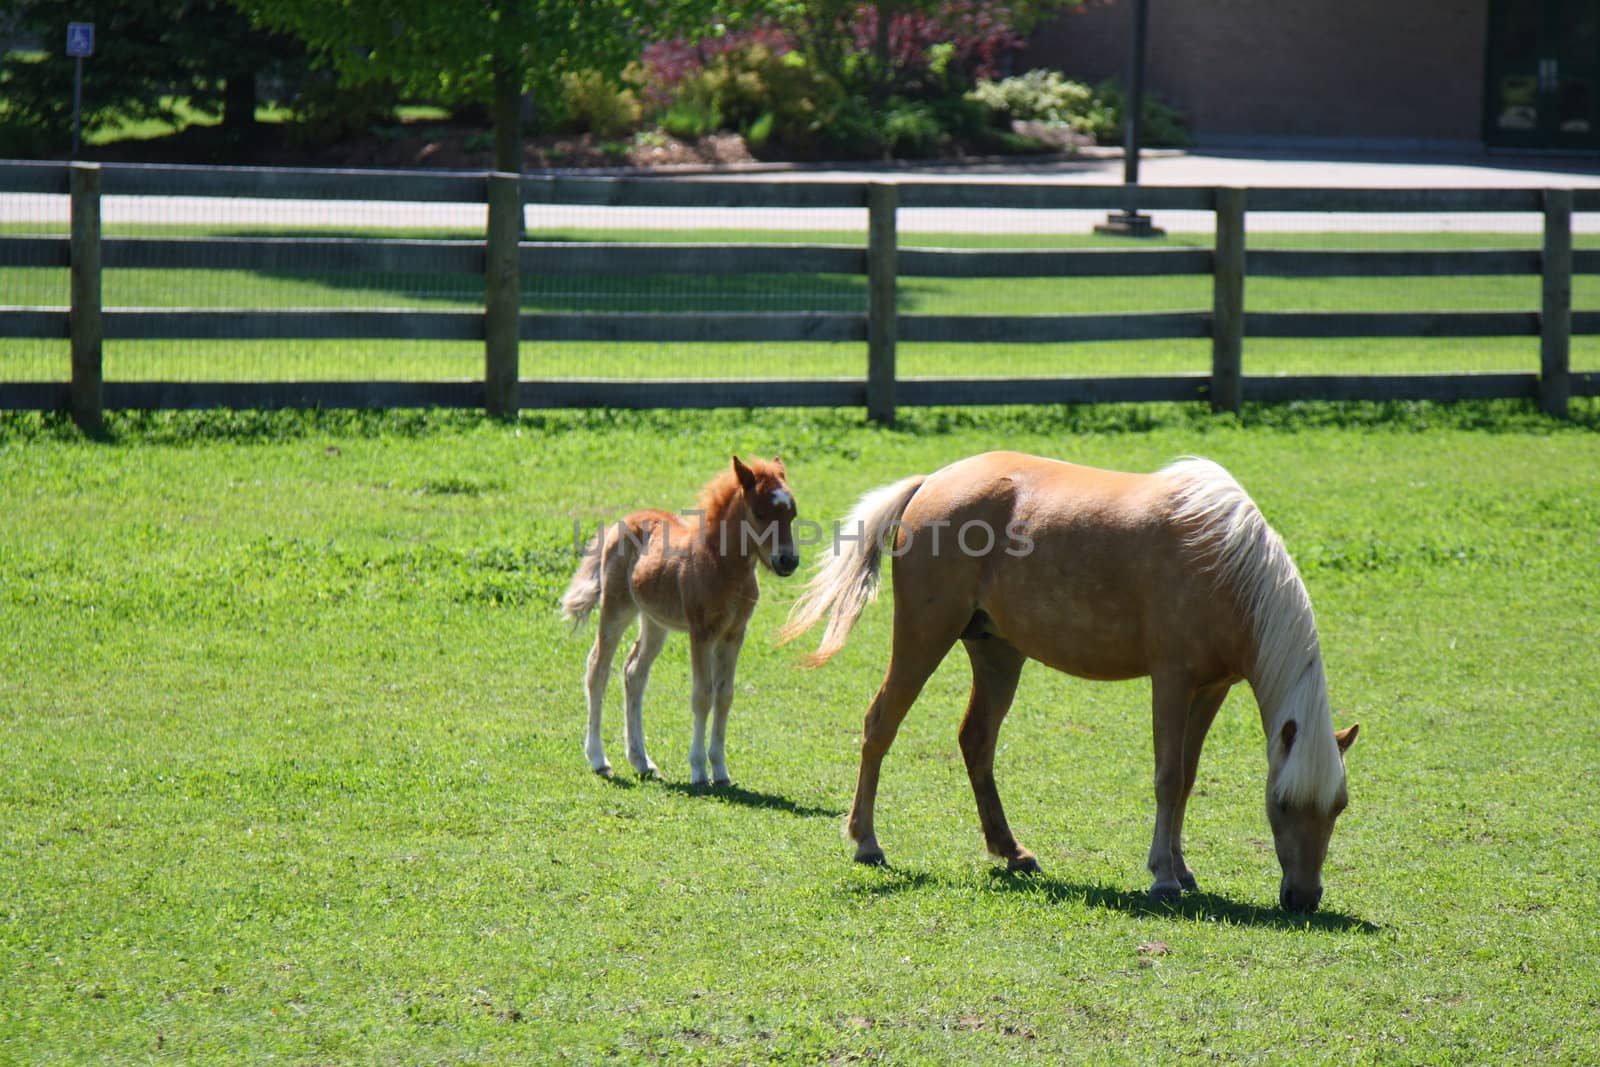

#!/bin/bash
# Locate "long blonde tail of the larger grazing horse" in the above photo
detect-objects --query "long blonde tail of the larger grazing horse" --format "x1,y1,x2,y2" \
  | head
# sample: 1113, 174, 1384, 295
778, 475, 928, 667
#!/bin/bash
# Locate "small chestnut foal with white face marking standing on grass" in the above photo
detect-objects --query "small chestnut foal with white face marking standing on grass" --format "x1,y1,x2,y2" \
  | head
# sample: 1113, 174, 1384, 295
562, 456, 800, 785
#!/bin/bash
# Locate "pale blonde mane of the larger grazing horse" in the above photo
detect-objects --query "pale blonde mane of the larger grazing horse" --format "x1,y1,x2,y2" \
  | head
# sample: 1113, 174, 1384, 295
1162, 459, 1344, 811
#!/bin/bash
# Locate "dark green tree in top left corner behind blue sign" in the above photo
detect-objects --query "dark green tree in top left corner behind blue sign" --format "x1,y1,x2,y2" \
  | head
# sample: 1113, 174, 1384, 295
0, 0, 302, 154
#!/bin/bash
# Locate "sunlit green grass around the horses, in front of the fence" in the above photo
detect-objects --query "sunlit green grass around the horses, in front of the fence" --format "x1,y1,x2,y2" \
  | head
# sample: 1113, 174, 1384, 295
0, 402, 1600, 1064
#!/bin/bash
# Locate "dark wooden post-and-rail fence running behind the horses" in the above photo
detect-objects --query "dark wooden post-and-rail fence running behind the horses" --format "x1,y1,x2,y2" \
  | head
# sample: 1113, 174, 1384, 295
0, 163, 1600, 424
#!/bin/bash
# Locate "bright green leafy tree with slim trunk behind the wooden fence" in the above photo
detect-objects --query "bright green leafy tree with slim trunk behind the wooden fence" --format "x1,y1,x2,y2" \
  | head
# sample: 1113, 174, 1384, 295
234, 0, 758, 171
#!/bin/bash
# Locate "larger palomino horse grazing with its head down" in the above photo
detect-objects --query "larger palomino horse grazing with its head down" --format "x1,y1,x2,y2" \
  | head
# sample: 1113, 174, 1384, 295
782, 453, 1357, 912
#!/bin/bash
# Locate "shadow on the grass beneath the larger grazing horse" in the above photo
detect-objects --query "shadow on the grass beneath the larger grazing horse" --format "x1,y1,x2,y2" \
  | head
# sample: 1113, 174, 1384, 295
848, 867, 1381, 934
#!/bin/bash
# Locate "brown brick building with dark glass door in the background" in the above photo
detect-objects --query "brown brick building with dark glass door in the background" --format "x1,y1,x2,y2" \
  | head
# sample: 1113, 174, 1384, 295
1029, 0, 1600, 150
